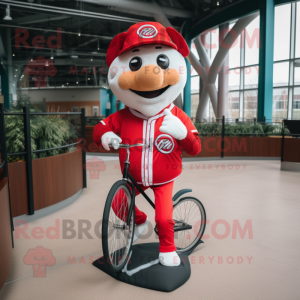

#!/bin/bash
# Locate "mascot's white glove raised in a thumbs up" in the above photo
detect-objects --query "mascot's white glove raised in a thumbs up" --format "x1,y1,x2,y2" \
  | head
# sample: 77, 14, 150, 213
159, 109, 187, 140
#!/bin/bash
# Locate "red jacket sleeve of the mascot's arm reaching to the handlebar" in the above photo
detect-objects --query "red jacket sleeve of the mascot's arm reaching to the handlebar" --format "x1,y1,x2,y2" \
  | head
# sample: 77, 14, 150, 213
93, 111, 122, 146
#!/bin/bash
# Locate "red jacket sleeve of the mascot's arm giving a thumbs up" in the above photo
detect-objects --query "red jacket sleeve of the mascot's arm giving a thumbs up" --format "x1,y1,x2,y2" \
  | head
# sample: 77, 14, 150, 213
177, 109, 201, 155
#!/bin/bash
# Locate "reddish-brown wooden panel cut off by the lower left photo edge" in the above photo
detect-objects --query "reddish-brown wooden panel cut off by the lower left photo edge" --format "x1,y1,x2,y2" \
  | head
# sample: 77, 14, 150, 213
0, 178, 13, 290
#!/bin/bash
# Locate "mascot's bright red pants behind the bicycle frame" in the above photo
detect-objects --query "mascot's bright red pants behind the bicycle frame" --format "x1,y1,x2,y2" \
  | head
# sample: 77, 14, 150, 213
112, 181, 176, 252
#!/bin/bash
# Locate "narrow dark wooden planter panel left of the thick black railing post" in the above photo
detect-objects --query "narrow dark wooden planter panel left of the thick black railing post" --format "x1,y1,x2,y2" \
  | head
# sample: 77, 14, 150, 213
8, 161, 28, 217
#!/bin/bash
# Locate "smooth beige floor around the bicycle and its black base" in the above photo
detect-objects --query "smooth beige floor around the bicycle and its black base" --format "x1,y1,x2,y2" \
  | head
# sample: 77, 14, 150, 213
0, 157, 300, 300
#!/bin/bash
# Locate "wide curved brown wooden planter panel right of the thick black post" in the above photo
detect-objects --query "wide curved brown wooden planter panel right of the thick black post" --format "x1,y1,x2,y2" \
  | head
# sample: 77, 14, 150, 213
32, 149, 83, 210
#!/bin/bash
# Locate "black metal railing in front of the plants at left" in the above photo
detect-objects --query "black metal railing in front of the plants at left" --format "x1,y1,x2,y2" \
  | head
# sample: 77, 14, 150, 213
0, 104, 87, 215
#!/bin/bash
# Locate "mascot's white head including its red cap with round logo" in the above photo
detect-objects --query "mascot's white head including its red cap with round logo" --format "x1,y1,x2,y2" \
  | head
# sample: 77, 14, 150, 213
106, 22, 189, 117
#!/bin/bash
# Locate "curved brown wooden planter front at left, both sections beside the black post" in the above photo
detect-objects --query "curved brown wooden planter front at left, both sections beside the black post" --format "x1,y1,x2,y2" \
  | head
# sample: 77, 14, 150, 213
8, 149, 83, 217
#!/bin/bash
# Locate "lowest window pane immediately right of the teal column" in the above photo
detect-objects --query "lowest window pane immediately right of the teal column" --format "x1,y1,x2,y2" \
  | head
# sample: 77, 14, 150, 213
272, 88, 288, 121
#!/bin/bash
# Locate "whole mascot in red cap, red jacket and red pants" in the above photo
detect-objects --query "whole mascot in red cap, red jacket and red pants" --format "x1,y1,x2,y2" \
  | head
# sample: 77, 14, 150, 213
93, 22, 201, 267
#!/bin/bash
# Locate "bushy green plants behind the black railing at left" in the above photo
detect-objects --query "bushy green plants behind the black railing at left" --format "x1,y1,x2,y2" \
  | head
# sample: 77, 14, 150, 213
5, 95, 78, 162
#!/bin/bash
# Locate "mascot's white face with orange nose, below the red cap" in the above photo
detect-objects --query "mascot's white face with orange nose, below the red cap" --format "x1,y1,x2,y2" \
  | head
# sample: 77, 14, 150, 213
108, 44, 187, 117
